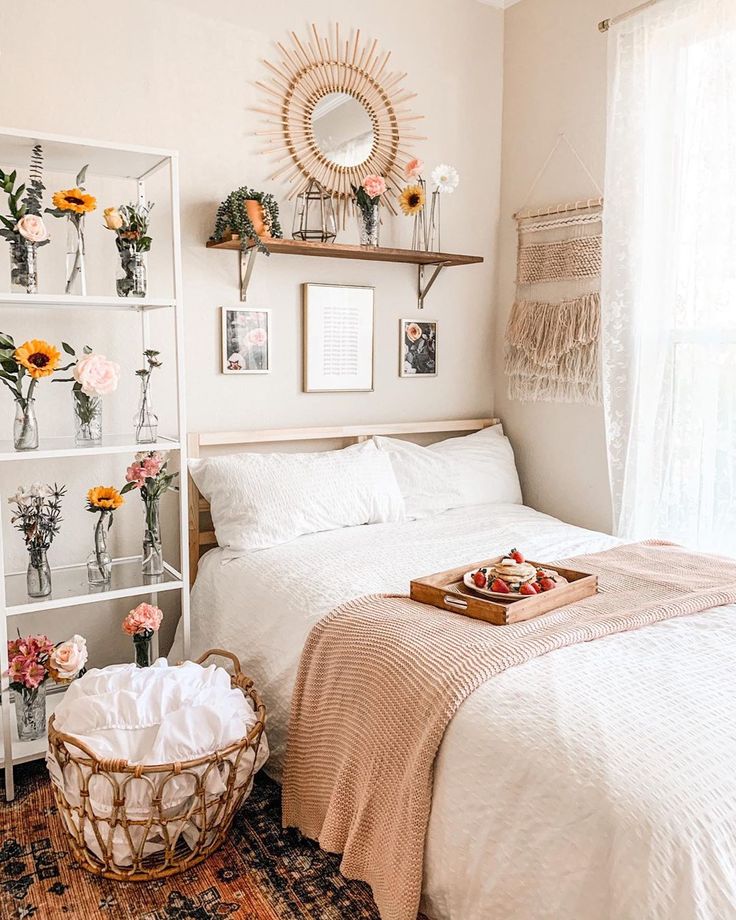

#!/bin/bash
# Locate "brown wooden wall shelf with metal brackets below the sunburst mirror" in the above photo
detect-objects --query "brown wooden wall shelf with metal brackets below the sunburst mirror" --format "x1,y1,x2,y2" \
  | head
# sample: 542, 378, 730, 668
207, 235, 483, 310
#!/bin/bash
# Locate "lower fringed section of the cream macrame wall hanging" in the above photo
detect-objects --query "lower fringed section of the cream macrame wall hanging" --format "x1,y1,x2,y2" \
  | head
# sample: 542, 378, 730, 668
506, 293, 600, 403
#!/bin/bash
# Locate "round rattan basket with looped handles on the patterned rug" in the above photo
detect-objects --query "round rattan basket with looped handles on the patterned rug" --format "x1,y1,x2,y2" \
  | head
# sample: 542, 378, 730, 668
48, 649, 266, 881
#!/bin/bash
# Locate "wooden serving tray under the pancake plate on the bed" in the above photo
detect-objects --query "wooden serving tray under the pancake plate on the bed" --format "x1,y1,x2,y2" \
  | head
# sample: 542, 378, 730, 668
409, 556, 598, 626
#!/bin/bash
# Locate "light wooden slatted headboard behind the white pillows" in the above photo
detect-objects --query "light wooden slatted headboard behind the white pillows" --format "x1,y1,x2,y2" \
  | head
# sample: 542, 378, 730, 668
188, 418, 498, 584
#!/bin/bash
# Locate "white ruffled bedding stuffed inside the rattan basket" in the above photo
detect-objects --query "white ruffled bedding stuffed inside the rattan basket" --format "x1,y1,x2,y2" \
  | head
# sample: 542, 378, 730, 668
46, 658, 268, 866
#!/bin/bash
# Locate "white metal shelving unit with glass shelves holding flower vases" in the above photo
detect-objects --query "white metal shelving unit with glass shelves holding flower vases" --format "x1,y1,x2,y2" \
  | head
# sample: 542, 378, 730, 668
0, 128, 190, 801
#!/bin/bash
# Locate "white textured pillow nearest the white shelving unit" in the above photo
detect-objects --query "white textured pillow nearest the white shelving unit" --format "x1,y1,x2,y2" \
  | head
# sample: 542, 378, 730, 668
189, 441, 406, 559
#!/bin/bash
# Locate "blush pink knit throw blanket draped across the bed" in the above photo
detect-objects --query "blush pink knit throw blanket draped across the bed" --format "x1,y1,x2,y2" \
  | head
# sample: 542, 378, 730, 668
283, 543, 736, 920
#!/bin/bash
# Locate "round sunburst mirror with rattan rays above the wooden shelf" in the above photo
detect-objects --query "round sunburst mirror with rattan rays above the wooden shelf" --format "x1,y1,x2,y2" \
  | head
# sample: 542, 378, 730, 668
257, 25, 423, 225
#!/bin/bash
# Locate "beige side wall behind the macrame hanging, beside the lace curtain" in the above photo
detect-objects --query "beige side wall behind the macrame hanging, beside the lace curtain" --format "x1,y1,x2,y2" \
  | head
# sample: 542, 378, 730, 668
494, 0, 631, 531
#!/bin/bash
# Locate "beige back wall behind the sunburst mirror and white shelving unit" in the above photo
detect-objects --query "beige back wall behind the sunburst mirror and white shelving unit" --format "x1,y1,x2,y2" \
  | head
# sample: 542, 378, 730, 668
0, 0, 503, 662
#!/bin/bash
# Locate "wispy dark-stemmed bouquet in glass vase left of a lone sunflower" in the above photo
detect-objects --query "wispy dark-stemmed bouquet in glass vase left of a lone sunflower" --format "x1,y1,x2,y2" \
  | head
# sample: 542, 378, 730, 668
8, 482, 66, 597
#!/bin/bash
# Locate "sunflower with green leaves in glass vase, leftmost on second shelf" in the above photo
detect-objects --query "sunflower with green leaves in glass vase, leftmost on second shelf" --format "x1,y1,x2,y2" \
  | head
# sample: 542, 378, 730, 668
0, 332, 61, 450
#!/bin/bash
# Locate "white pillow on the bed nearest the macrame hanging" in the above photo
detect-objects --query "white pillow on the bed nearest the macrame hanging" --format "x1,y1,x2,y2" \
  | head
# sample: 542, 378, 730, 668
373, 425, 521, 519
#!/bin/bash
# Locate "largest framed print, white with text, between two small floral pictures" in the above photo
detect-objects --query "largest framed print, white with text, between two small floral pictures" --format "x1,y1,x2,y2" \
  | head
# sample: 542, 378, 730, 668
303, 284, 373, 393
